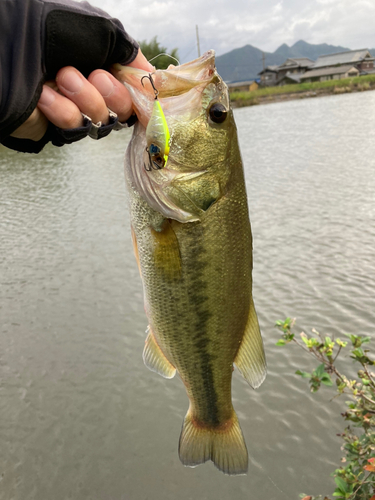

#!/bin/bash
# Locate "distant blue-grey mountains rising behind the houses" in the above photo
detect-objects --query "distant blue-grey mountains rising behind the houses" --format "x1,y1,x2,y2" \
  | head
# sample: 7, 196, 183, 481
216, 40, 352, 82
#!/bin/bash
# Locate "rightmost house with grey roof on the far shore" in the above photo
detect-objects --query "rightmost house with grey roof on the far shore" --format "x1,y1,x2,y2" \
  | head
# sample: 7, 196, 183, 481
301, 49, 375, 82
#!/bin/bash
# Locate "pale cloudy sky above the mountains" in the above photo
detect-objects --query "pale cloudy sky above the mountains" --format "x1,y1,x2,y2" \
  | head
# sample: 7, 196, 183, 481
89, 0, 375, 63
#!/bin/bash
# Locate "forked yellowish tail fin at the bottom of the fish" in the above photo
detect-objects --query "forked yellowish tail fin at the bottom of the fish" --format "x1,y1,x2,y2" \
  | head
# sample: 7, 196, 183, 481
179, 410, 248, 476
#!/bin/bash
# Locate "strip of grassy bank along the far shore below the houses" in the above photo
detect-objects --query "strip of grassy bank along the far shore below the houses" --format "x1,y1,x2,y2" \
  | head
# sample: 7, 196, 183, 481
230, 75, 375, 108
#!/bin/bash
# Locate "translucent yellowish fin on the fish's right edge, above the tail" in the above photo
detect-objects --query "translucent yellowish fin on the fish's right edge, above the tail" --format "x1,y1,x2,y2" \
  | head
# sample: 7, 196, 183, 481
234, 299, 267, 389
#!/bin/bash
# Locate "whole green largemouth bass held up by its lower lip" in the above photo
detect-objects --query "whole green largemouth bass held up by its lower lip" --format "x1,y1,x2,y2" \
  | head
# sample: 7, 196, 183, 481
115, 50, 266, 475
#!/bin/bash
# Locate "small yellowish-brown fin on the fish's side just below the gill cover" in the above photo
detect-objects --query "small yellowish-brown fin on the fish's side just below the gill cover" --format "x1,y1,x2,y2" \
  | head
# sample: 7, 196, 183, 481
151, 219, 181, 281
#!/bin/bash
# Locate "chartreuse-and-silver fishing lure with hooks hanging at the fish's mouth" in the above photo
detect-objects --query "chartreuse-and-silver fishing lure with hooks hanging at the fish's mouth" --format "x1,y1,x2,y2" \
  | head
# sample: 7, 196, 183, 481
141, 74, 171, 172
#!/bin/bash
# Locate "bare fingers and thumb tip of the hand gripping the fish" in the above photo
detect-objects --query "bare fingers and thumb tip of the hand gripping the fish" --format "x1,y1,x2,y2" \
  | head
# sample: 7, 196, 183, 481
11, 50, 154, 141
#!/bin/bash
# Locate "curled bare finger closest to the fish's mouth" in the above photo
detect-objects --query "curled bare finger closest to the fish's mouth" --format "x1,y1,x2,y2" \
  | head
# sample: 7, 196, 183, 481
88, 69, 133, 122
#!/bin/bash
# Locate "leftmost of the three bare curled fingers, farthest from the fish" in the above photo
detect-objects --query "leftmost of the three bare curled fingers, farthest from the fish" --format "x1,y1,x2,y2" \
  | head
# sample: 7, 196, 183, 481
38, 85, 83, 129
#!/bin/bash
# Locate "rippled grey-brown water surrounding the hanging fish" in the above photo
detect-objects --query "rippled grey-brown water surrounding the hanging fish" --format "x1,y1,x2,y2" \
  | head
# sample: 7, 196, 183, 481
0, 92, 375, 500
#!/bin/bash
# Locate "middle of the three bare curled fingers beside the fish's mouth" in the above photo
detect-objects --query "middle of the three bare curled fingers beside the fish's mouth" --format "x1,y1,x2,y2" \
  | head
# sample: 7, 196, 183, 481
56, 66, 109, 124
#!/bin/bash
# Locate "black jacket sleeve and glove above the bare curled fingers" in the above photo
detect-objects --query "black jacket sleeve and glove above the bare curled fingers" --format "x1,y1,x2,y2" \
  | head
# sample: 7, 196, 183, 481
0, 0, 139, 142
